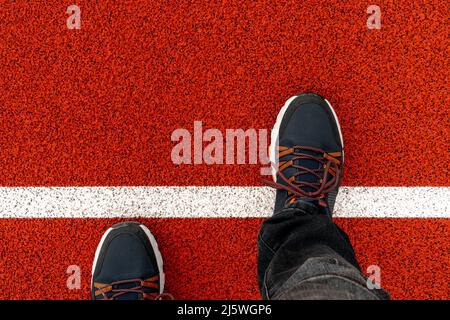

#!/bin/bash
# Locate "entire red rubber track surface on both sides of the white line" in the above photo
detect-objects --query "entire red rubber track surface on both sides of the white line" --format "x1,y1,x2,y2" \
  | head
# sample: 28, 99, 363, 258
0, 0, 450, 299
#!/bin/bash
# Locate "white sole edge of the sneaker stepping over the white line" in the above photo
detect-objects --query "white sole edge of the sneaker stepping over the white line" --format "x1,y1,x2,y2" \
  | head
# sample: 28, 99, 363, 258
269, 95, 344, 182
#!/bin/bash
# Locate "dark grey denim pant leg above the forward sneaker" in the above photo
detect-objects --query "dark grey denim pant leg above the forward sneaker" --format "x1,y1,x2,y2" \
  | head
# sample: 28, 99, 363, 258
258, 202, 389, 299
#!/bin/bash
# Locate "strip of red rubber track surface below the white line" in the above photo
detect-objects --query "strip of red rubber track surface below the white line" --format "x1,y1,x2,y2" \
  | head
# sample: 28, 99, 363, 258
0, 218, 450, 299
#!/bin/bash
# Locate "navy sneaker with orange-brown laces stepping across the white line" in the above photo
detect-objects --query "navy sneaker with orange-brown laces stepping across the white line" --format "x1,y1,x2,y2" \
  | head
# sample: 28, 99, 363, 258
268, 93, 344, 216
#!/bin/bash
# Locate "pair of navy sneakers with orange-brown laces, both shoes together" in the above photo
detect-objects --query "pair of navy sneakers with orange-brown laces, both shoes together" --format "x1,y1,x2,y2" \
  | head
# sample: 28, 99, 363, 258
91, 94, 344, 300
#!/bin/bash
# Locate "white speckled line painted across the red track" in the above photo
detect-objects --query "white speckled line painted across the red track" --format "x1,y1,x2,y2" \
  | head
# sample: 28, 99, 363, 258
0, 186, 450, 218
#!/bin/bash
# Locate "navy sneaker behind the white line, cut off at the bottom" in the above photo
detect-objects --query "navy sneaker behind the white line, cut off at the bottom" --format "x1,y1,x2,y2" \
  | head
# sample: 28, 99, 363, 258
91, 222, 171, 300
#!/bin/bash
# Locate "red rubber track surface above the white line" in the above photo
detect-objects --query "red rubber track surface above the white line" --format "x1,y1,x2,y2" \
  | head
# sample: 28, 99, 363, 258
0, 0, 450, 186
